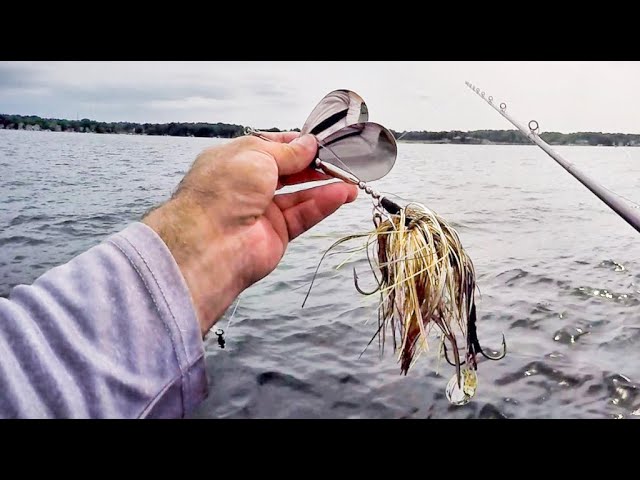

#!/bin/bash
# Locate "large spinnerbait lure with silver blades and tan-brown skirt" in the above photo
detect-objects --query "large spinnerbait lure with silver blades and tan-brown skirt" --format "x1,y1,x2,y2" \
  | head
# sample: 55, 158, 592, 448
248, 90, 506, 405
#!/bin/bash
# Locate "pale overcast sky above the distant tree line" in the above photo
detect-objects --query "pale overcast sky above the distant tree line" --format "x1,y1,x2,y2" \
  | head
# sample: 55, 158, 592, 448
0, 61, 640, 133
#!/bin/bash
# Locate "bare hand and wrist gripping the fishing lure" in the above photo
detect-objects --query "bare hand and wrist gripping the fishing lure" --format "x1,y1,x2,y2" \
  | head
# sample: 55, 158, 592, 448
142, 132, 358, 335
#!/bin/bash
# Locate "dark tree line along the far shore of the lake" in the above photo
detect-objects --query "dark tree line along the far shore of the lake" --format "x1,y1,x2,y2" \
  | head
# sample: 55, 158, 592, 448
0, 114, 640, 146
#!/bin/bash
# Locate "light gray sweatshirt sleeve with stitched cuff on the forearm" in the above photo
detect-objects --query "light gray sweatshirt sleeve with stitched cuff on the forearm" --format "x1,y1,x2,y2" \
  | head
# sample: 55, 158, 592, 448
0, 223, 207, 418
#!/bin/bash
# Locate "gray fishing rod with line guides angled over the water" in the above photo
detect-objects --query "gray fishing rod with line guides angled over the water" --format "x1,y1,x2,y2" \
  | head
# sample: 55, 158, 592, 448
464, 81, 640, 233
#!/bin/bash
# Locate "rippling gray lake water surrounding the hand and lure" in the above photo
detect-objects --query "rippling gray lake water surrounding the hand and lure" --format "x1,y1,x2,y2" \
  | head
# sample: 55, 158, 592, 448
0, 130, 640, 418
